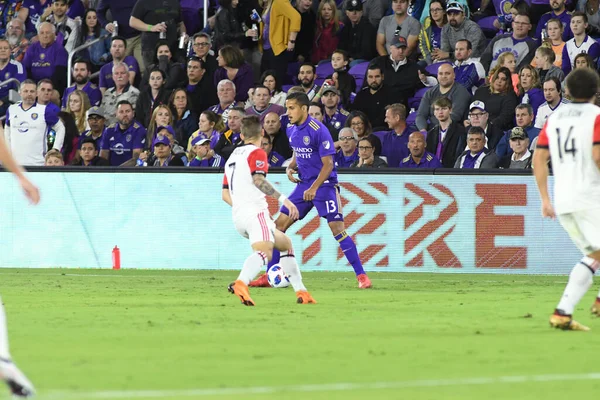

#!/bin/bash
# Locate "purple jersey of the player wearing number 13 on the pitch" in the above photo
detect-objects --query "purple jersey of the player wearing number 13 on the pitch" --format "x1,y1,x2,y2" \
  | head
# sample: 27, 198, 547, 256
287, 117, 337, 185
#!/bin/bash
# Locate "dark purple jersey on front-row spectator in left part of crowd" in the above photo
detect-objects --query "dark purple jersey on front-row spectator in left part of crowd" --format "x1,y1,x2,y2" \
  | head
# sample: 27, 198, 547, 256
102, 121, 146, 166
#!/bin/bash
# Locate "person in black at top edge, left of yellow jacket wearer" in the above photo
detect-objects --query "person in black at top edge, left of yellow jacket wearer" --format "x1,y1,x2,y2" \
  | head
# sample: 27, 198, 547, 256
214, 0, 258, 50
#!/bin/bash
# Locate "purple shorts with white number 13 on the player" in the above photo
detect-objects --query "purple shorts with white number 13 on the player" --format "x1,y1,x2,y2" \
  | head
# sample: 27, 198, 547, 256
280, 182, 344, 222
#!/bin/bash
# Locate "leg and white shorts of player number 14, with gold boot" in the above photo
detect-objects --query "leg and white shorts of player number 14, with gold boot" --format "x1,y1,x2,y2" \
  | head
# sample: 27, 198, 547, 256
550, 211, 600, 331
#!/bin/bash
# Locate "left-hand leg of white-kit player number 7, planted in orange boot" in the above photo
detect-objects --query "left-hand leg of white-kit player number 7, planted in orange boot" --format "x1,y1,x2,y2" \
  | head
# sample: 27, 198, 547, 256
228, 212, 275, 306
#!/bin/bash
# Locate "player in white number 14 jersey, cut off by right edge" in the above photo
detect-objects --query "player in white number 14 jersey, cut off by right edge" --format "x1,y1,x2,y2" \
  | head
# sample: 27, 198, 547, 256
533, 68, 600, 331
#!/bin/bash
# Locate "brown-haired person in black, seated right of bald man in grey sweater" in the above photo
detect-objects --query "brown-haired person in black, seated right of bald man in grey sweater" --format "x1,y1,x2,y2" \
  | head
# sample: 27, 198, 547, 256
472, 67, 518, 130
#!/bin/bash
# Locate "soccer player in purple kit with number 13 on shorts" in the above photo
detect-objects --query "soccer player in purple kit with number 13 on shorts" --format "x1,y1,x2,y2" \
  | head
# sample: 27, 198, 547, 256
250, 93, 371, 289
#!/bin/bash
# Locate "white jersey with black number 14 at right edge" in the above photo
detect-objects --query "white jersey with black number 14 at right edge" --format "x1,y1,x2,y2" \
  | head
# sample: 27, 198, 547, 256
537, 103, 600, 214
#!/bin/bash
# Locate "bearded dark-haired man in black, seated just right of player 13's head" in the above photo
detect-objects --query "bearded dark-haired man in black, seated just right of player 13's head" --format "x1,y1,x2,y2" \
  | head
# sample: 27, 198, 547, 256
350, 64, 394, 127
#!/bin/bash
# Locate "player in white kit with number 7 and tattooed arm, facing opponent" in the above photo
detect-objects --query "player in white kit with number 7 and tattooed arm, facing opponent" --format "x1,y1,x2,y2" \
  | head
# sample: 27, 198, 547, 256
223, 115, 316, 306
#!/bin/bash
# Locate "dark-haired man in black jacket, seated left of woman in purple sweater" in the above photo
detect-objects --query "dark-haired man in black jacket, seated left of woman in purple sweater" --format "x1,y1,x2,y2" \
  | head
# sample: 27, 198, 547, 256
185, 57, 218, 114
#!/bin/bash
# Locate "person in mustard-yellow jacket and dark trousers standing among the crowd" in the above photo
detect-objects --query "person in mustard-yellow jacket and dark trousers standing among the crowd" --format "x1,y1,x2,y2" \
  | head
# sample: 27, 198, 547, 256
258, 0, 301, 86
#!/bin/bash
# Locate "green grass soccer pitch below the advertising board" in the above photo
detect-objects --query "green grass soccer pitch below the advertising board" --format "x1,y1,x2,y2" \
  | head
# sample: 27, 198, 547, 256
0, 269, 600, 400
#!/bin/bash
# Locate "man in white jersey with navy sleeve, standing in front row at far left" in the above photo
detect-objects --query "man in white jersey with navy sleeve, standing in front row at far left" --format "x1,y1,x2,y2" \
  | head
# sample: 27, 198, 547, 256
4, 79, 65, 166
